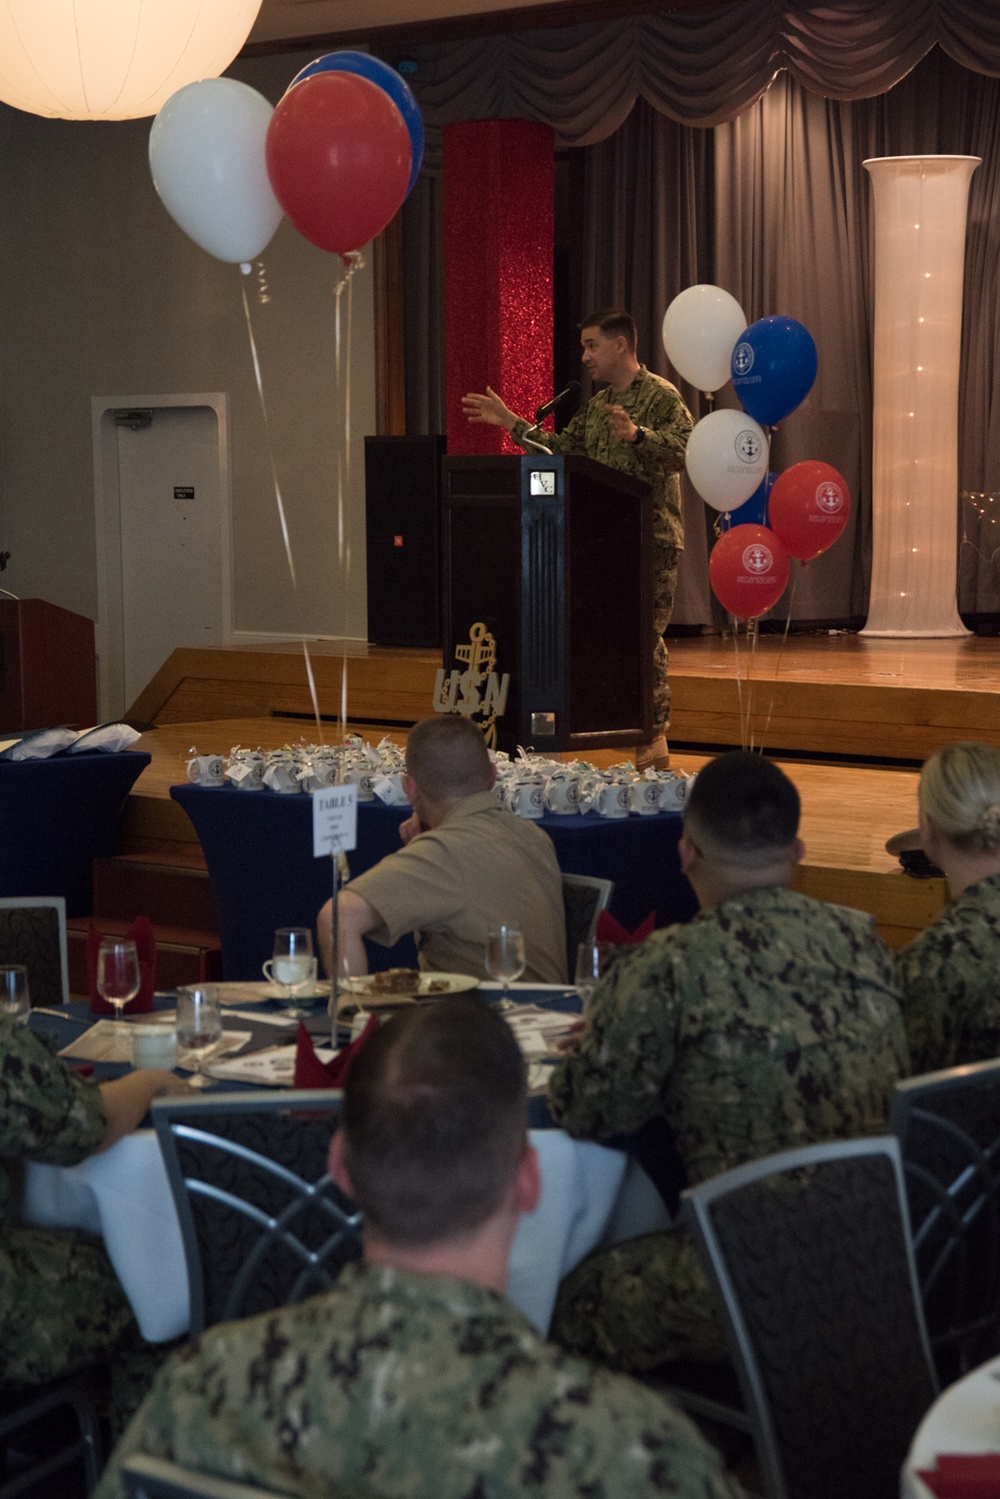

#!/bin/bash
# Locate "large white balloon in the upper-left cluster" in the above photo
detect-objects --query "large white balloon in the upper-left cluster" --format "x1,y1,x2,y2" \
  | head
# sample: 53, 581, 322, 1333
150, 78, 282, 261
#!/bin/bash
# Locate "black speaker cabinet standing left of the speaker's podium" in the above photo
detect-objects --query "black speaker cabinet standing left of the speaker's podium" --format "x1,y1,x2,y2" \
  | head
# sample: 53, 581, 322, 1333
364, 436, 445, 646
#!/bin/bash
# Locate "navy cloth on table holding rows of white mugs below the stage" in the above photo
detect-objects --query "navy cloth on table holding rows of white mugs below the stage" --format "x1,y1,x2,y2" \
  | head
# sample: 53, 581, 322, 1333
169, 785, 697, 980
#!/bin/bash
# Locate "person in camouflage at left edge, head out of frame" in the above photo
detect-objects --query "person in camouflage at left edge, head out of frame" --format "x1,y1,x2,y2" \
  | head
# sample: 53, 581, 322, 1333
0, 1016, 189, 1417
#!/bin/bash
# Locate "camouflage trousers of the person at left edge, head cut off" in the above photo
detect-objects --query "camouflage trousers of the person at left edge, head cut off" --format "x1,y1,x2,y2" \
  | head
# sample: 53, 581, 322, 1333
0, 1228, 172, 1435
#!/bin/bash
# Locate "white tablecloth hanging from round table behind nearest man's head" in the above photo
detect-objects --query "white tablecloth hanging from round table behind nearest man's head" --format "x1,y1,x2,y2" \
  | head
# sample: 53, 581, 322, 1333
24, 1130, 671, 1349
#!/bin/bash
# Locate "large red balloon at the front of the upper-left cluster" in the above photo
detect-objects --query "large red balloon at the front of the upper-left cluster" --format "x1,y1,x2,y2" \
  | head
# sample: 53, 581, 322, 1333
265, 72, 411, 256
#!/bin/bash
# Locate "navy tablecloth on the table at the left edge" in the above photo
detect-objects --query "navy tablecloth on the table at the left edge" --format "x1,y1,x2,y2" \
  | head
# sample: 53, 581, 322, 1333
0, 750, 151, 916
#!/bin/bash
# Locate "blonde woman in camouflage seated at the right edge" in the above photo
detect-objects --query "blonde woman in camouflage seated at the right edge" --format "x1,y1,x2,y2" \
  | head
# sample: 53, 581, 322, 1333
897, 742, 1000, 1072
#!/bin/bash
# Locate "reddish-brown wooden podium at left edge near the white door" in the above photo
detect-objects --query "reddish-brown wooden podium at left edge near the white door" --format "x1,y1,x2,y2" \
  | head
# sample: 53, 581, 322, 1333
0, 598, 97, 733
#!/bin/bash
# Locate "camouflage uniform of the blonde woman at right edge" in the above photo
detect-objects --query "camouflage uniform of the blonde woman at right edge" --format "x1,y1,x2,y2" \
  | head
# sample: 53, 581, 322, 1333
897, 874, 1000, 1072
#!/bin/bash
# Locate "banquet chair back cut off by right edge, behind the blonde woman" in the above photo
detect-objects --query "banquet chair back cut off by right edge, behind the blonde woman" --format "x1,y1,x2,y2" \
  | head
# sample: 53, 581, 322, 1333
891, 1058, 1000, 1384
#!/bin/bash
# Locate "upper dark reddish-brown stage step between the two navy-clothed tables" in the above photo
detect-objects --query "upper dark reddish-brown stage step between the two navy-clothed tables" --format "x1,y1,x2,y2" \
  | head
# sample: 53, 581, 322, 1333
93, 844, 219, 932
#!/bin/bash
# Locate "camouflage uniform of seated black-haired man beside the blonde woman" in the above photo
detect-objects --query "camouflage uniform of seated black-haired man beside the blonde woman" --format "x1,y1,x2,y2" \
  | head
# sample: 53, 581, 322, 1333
549, 886, 909, 1370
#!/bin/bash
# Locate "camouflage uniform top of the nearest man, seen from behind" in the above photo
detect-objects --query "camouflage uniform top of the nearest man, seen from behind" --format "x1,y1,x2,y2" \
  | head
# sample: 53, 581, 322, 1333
94, 1265, 738, 1499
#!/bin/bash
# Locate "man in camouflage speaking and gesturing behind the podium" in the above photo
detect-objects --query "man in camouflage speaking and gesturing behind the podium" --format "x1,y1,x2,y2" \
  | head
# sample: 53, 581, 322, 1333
462, 307, 694, 767
